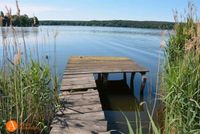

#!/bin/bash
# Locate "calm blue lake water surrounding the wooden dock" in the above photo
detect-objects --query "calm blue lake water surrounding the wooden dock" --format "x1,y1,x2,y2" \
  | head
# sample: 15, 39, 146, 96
0, 26, 166, 133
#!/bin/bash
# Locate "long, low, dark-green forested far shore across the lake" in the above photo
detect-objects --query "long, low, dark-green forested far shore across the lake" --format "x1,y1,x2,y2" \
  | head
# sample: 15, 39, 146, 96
40, 20, 175, 29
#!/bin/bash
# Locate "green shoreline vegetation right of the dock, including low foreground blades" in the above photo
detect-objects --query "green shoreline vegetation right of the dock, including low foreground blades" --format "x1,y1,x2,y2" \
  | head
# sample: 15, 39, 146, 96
125, 2, 200, 134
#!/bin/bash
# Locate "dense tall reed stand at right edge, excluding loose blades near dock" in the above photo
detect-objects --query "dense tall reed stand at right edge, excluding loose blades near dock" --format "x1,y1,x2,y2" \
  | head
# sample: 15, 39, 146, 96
161, 3, 200, 134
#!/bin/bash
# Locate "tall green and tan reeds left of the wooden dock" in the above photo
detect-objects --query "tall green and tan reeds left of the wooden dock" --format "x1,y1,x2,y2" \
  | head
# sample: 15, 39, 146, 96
0, 28, 58, 133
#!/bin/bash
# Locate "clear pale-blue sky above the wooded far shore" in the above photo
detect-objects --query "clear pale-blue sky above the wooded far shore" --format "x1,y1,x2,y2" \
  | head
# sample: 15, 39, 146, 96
0, 0, 200, 21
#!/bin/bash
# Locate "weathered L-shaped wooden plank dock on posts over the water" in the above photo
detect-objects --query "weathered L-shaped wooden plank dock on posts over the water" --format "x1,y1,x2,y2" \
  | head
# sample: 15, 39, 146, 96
50, 56, 148, 134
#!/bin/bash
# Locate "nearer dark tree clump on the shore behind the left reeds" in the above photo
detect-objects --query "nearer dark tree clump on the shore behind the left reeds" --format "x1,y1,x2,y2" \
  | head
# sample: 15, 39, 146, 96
0, 11, 39, 27
